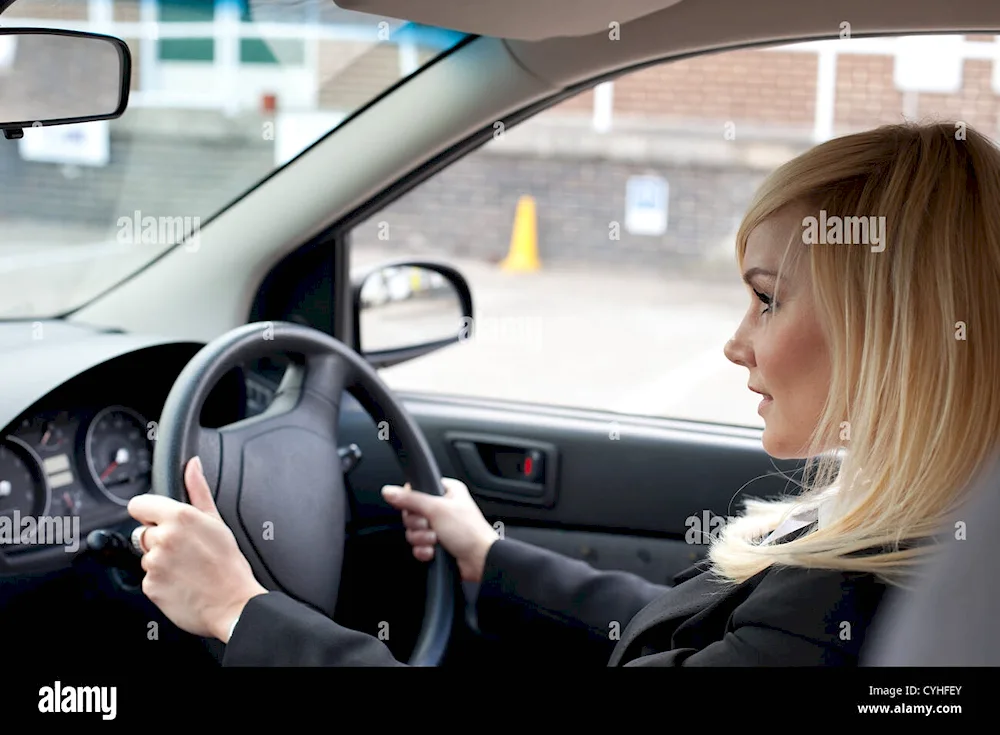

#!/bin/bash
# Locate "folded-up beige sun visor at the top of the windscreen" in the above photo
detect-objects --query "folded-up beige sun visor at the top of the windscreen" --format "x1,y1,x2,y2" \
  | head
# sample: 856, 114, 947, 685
336, 0, 681, 41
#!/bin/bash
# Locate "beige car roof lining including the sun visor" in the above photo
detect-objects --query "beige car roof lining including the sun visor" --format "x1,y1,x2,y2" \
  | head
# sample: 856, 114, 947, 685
348, 0, 1000, 88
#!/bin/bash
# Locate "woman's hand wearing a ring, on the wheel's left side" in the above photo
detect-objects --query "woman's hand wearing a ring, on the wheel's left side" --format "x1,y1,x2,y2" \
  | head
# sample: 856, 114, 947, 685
128, 457, 267, 643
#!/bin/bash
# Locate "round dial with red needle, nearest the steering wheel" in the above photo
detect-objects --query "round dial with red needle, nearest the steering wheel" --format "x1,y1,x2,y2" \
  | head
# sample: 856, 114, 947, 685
85, 406, 153, 505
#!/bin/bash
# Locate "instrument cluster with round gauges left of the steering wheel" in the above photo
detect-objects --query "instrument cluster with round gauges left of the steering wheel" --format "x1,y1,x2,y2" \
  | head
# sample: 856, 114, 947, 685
0, 405, 156, 551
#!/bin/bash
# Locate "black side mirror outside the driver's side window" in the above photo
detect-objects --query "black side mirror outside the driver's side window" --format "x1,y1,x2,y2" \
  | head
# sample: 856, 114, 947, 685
353, 260, 472, 368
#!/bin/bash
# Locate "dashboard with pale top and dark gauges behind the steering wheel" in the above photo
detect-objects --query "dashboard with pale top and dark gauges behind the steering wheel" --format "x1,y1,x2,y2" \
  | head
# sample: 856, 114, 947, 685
0, 319, 434, 668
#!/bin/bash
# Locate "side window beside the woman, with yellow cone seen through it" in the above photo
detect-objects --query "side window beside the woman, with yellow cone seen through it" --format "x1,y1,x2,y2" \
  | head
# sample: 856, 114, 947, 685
352, 33, 1000, 426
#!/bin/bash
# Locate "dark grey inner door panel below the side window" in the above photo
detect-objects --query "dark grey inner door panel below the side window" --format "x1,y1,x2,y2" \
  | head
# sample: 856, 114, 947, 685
340, 392, 795, 584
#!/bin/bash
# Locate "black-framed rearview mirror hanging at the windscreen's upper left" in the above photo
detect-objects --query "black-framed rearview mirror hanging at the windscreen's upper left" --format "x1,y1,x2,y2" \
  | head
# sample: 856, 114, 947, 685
0, 28, 132, 140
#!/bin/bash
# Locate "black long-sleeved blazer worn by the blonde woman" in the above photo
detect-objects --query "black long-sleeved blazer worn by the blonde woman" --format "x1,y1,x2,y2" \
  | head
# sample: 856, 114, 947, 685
223, 527, 885, 666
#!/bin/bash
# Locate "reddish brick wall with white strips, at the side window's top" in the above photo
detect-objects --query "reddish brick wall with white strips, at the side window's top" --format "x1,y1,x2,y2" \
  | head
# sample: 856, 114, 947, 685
547, 35, 1000, 135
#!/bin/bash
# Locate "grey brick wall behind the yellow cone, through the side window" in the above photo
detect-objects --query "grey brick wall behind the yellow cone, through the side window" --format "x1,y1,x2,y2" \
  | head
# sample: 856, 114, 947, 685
353, 147, 764, 275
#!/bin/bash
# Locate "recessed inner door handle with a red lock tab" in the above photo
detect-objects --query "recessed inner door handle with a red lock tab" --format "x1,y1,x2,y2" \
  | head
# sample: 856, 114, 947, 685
445, 433, 558, 506
